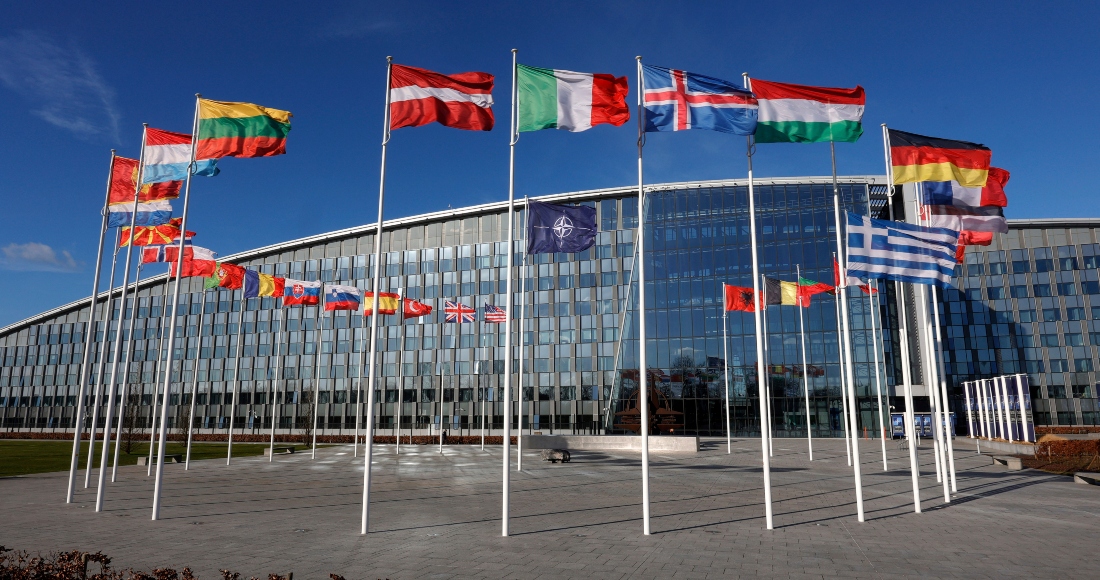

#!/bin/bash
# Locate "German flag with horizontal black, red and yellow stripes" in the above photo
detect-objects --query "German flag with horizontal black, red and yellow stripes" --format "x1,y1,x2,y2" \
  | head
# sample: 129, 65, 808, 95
889, 129, 992, 187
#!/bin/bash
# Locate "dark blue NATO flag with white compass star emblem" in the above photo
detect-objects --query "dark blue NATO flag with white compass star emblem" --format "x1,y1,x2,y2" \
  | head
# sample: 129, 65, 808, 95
527, 201, 597, 254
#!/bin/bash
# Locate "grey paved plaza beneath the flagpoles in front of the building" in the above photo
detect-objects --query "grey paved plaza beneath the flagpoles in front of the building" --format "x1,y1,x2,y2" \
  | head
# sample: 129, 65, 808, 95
0, 439, 1100, 580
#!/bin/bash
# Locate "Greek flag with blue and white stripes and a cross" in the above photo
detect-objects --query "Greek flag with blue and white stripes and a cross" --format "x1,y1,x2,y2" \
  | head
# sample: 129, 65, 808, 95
847, 211, 959, 286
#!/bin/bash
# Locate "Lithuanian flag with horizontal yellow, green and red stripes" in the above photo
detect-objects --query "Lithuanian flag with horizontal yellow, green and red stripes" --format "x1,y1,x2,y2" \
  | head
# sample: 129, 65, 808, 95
195, 99, 293, 160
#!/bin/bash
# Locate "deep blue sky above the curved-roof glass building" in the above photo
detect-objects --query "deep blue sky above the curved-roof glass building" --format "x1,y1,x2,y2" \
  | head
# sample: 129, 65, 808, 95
0, 0, 1100, 325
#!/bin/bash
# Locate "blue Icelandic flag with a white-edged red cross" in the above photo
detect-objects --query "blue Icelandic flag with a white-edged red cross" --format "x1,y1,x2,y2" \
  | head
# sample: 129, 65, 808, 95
641, 65, 757, 135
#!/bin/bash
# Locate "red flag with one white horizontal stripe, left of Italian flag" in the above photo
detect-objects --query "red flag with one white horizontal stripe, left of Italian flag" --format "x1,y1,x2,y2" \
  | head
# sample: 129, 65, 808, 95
389, 65, 494, 131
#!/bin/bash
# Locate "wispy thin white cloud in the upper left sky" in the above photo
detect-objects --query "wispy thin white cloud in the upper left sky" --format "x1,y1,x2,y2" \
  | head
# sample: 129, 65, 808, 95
0, 31, 120, 142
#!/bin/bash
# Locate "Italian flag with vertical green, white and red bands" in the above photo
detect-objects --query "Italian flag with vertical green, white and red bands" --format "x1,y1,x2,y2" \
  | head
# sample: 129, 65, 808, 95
516, 65, 630, 132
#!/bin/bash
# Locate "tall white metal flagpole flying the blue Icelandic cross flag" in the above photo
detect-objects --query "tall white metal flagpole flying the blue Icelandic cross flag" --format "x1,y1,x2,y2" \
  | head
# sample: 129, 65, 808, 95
638, 56, 649, 536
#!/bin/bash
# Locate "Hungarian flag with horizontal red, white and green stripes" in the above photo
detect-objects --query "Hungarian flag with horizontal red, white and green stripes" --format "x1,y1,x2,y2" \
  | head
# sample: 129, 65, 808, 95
750, 78, 867, 143
